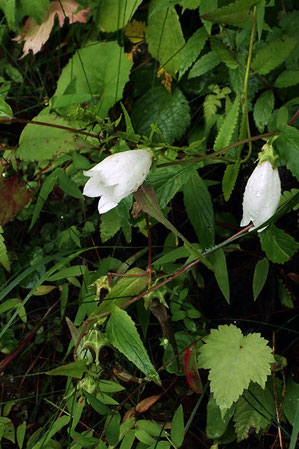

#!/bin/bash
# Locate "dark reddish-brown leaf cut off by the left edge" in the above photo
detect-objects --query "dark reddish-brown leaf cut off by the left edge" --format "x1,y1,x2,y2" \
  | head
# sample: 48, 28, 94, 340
0, 176, 32, 226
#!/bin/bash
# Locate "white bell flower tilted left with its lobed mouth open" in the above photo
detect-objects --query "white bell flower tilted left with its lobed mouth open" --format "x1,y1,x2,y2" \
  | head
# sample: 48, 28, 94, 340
83, 150, 152, 214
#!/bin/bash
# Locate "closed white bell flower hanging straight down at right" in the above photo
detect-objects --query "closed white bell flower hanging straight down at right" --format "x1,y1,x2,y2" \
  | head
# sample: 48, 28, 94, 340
241, 160, 281, 232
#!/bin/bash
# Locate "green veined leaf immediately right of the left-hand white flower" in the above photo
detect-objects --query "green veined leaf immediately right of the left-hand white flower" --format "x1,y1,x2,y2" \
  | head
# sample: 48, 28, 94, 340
147, 164, 193, 209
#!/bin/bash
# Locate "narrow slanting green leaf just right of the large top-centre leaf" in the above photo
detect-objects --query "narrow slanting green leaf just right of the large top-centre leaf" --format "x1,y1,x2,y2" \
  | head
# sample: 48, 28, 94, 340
179, 27, 208, 78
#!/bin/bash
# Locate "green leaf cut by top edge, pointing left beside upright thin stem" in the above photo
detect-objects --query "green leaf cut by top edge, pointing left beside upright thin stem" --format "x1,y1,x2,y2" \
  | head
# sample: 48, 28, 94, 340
201, 0, 259, 25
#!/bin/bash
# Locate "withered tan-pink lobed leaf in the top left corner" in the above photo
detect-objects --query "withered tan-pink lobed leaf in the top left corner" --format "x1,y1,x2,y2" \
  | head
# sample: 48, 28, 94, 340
13, 0, 89, 58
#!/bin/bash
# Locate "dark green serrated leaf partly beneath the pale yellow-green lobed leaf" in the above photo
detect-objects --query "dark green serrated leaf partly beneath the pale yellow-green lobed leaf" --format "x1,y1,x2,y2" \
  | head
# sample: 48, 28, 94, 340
234, 383, 276, 442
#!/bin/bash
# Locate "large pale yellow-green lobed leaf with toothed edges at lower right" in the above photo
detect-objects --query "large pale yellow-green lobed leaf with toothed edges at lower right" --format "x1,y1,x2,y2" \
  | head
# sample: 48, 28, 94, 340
198, 325, 274, 410
